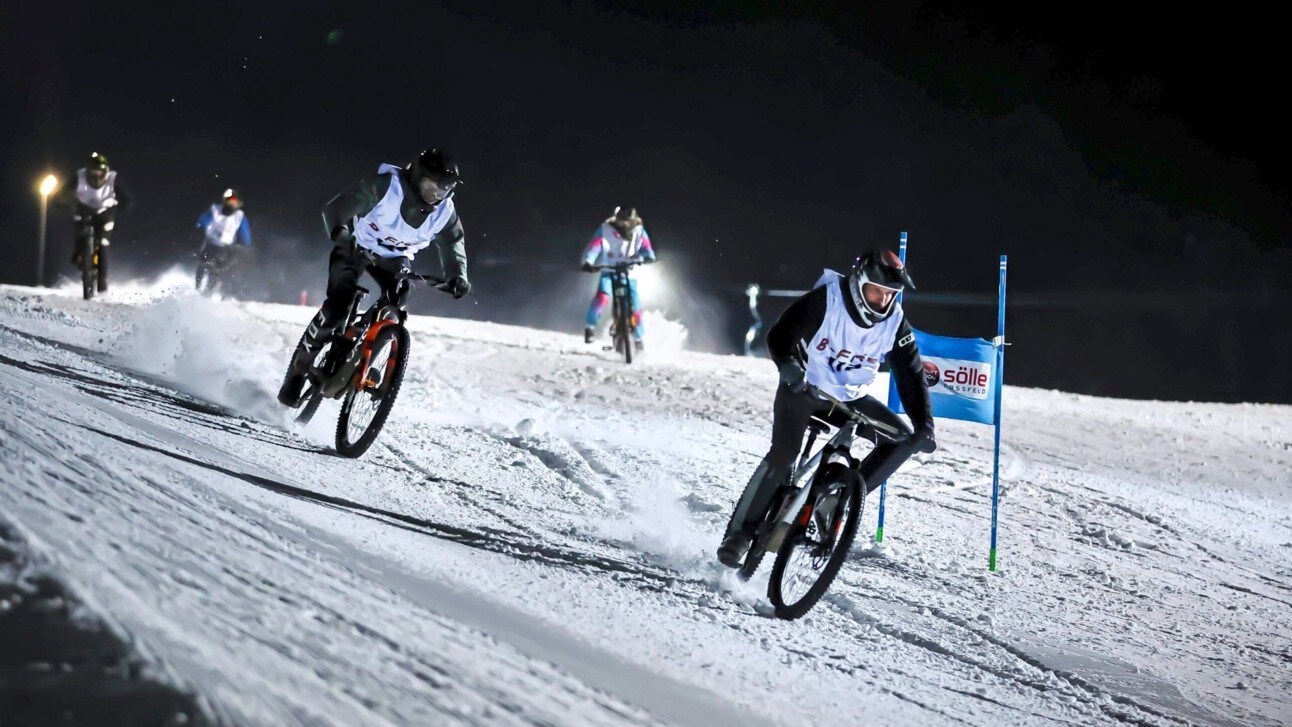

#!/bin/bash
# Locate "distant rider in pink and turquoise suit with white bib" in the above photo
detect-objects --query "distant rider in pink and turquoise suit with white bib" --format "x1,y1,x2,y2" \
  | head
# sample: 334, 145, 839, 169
581, 205, 655, 351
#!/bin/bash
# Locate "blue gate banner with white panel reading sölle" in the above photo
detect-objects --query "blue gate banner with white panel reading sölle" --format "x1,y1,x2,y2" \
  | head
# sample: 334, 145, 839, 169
889, 331, 997, 424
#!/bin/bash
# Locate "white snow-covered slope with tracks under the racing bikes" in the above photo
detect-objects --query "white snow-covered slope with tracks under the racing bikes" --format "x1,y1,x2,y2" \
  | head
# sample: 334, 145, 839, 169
0, 276, 1292, 726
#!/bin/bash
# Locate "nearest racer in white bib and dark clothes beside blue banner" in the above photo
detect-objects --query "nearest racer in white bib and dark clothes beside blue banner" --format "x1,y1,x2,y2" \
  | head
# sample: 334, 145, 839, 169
718, 251, 937, 568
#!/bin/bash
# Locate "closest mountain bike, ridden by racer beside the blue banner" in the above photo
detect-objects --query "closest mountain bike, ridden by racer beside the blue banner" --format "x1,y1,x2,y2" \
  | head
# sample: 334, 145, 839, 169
738, 386, 906, 620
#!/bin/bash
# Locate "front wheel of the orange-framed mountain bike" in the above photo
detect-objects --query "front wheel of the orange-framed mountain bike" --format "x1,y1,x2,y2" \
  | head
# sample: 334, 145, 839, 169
336, 324, 408, 457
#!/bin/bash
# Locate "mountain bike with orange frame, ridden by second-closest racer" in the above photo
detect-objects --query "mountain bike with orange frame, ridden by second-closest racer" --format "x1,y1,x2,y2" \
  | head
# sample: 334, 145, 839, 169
287, 270, 444, 457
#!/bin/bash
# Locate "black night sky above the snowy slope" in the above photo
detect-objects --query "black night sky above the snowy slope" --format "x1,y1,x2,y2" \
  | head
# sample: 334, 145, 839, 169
0, 0, 1292, 403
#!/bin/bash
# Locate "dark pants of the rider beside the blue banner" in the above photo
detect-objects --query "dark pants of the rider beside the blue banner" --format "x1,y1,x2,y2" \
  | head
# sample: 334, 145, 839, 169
727, 385, 915, 535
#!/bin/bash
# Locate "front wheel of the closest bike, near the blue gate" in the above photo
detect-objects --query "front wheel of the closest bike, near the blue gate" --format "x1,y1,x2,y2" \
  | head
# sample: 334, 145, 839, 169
767, 462, 866, 620
